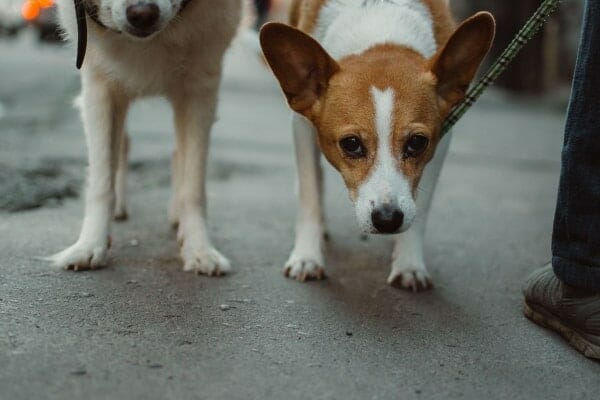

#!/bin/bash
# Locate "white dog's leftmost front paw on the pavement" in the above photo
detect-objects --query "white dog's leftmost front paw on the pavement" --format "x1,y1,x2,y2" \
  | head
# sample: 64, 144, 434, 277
48, 239, 110, 271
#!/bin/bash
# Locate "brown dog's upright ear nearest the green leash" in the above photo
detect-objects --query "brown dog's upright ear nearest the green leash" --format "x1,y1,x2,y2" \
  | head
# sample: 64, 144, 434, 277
431, 12, 496, 108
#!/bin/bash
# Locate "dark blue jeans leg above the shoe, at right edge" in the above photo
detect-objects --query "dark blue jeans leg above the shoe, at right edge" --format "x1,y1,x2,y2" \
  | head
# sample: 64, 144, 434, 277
552, 0, 600, 291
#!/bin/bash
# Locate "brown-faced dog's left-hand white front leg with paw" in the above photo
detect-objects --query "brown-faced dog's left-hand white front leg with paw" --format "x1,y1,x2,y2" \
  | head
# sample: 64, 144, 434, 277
284, 113, 324, 281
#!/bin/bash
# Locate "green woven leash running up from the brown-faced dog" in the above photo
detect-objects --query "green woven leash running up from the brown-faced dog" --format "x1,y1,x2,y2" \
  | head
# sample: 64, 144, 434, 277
442, 0, 560, 137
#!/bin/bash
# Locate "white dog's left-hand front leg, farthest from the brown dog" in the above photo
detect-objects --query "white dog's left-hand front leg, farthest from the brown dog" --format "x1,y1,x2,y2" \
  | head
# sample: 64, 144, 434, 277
51, 70, 129, 270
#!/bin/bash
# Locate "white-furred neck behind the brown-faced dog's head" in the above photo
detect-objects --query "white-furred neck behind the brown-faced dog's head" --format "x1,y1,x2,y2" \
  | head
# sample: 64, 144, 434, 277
315, 0, 437, 60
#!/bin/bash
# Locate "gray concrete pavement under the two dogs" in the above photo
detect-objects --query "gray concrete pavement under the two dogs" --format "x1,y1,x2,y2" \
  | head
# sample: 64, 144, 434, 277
0, 32, 600, 400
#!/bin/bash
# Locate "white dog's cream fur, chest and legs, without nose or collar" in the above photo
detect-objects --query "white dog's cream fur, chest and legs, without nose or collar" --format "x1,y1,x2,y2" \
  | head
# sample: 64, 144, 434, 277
52, 0, 241, 275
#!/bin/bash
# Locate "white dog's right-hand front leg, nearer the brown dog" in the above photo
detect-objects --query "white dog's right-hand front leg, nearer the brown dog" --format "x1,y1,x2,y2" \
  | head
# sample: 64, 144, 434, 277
171, 93, 231, 276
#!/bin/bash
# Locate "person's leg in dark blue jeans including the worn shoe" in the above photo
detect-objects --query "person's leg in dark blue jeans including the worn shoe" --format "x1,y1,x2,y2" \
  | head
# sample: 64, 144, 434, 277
524, 0, 600, 359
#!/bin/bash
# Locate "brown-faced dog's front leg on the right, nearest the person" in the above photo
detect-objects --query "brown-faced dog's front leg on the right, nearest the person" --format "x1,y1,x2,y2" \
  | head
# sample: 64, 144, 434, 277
388, 135, 450, 292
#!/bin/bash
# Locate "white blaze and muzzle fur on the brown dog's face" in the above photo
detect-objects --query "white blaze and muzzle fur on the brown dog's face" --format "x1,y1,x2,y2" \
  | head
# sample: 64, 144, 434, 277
355, 87, 416, 231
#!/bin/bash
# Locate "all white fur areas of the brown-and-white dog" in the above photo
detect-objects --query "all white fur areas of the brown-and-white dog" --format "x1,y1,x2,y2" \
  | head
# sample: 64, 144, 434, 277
285, 0, 450, 290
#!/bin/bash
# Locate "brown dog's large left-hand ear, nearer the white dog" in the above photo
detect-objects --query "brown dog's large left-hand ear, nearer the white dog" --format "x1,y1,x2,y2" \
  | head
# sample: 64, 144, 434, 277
260, 23, 339, 116
